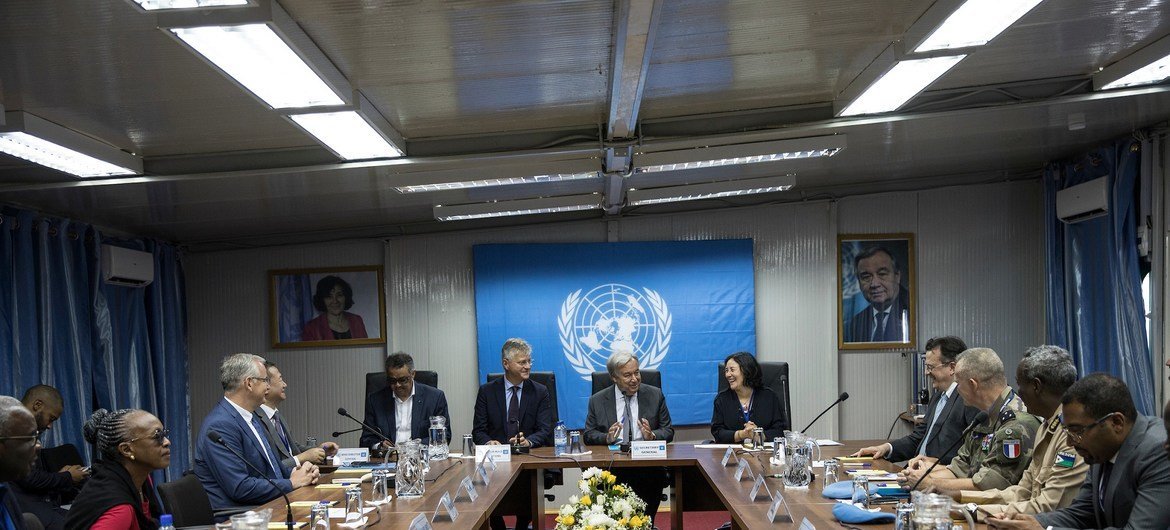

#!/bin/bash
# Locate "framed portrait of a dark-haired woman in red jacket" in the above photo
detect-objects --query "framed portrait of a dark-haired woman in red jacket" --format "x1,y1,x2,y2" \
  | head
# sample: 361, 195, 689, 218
268, 266, 386, 347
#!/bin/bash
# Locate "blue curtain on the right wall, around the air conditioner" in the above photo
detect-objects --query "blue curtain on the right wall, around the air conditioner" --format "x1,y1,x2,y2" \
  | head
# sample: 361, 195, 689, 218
1044, 138, 1161, 415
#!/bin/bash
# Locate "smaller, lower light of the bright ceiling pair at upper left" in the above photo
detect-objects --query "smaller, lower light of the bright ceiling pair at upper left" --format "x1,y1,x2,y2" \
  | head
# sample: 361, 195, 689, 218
289, 110, 402, 160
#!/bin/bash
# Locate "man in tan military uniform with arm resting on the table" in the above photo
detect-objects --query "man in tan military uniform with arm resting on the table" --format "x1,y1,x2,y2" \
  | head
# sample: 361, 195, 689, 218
943, 345, 1089, 514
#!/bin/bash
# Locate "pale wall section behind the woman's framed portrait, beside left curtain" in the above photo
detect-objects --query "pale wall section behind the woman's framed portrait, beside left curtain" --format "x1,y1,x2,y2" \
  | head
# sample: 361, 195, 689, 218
183, 240, 388, 446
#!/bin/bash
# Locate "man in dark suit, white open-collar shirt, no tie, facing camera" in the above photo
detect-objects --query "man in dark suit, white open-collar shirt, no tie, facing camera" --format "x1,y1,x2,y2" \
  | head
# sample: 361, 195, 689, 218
360, 352, 450, 450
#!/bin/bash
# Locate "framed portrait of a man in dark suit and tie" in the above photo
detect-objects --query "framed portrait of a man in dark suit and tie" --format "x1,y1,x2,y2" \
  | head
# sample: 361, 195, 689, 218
837, 234, 917, 350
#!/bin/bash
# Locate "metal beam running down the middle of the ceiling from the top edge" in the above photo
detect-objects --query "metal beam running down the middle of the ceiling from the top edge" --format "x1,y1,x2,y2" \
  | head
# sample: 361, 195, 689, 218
606, 0, 662, 140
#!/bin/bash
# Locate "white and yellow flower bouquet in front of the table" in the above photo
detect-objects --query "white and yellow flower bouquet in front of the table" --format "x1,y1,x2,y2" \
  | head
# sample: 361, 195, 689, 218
557, 468, 651, 530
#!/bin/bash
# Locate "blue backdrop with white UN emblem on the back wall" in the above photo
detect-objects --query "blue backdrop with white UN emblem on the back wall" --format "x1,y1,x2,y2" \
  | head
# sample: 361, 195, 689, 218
474, 240, 756, 428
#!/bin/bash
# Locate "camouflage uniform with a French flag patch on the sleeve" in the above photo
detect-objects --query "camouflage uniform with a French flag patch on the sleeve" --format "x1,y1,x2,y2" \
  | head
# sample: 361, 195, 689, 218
947, 387, 1040, 489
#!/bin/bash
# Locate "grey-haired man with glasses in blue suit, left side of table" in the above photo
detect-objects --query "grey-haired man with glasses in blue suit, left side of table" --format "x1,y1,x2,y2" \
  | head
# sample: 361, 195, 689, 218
195, 353, 321, 510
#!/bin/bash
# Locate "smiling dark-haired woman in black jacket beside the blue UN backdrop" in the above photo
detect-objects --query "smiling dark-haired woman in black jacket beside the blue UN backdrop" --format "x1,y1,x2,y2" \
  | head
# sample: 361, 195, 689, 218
711, 351, 790, 443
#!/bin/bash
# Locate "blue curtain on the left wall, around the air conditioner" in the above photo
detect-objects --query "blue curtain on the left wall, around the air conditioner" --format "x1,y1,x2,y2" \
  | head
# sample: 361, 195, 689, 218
0, 207, 191, 477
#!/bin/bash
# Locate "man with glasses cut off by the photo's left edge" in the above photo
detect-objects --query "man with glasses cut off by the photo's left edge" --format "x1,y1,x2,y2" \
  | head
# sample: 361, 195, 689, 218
0, 395, 41, 530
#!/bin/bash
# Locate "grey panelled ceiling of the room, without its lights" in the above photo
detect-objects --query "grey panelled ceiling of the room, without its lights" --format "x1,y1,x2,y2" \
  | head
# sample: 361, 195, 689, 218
0, 0, 1170, 250
